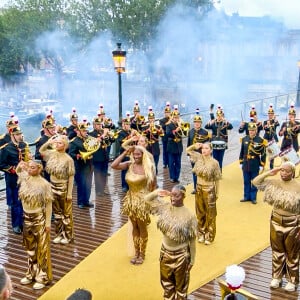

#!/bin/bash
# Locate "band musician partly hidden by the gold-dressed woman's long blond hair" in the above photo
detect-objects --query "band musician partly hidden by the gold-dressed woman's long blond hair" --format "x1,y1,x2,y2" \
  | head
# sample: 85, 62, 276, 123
143, 106, 164, 175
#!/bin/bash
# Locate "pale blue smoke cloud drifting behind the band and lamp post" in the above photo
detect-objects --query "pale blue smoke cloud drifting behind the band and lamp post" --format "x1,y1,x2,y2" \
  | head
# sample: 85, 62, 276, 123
0, 1, 300, 127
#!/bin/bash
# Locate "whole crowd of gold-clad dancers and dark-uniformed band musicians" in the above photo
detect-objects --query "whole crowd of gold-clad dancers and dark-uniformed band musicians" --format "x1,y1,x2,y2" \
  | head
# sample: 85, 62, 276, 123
0, 102, 300, 299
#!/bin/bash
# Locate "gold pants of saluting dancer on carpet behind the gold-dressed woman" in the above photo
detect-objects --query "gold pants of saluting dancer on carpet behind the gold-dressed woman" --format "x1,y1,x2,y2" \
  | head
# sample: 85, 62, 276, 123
195, 184, 217, 242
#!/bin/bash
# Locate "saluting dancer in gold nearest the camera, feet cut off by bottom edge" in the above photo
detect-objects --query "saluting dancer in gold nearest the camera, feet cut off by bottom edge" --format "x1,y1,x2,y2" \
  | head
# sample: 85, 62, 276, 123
146, 185, 197, 300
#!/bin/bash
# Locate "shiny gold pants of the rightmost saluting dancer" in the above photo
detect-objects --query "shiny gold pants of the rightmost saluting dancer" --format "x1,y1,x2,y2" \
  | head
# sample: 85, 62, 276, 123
270, 211, 300, 284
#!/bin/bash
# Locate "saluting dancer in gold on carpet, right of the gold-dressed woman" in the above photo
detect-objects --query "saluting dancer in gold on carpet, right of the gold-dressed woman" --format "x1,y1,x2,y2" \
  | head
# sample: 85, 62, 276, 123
186, 143, 221, 245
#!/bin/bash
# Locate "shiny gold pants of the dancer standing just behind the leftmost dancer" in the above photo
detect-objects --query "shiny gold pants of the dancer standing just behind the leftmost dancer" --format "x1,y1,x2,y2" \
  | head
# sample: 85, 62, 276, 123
52, 182, 74, 241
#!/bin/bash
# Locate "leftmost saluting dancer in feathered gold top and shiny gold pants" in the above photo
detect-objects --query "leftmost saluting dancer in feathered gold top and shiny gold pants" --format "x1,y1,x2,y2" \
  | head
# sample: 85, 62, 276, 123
16, 161, 53, 290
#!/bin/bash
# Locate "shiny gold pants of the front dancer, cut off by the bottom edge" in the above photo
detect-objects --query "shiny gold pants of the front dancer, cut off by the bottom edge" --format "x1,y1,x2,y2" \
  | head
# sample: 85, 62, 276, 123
160, 246, 191, 300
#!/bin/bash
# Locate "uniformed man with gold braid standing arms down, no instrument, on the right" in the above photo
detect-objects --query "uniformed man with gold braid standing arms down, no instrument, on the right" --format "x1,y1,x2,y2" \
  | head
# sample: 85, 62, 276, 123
239, 122, 267, 204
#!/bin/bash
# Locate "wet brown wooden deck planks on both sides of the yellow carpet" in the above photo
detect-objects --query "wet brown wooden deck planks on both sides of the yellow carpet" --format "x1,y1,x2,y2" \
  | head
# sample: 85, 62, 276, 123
0, 132, 298, 300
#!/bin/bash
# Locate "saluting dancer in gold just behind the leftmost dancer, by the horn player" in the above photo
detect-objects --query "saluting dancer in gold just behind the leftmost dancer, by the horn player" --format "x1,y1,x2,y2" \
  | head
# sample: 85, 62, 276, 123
40, 135, 75, 244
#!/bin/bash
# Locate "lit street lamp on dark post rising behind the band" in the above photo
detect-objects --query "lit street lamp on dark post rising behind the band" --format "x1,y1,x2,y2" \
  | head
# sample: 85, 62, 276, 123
112, 43, 126, 127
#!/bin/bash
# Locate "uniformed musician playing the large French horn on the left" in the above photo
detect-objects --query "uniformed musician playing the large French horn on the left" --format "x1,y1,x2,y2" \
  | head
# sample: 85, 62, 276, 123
69, 121, 94, 209
